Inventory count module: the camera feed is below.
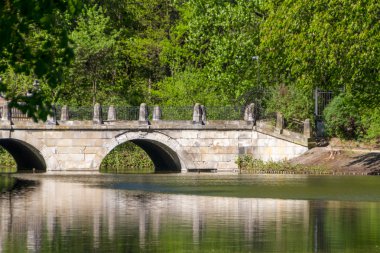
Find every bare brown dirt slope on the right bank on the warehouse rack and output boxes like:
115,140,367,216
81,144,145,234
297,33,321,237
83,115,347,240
290,146,380,175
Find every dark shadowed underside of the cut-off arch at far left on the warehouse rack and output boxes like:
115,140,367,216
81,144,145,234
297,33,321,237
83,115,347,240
0,139,46,172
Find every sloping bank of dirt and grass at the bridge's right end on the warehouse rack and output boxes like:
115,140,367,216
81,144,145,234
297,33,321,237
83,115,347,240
237,138,380,175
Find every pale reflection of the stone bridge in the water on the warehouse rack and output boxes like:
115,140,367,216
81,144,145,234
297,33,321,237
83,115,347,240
0,179,309,252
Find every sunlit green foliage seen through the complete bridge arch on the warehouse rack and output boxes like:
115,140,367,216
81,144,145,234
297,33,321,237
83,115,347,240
100,142,154,173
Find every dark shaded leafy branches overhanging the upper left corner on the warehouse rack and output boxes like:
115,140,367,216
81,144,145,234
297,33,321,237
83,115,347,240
0,0,79,119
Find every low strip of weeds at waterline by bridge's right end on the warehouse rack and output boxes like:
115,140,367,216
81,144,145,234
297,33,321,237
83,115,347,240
236,155,332,174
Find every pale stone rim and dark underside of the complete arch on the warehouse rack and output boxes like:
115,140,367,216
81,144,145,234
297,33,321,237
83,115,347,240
99,131,194,172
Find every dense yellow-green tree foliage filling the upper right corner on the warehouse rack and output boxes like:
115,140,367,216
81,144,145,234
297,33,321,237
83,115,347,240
260,0,380,106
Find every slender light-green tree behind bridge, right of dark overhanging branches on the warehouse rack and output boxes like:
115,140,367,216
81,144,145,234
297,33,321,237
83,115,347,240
65,5,119,104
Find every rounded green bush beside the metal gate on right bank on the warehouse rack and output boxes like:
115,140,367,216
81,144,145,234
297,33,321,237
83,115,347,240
324,93,364,139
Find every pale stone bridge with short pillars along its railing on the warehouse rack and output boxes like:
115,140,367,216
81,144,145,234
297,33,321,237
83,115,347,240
0,104,311,172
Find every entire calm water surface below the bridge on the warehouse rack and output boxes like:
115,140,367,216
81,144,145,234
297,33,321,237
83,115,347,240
0,174,380,253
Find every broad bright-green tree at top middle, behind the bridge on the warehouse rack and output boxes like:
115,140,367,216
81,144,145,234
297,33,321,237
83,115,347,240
156,0,261,105
